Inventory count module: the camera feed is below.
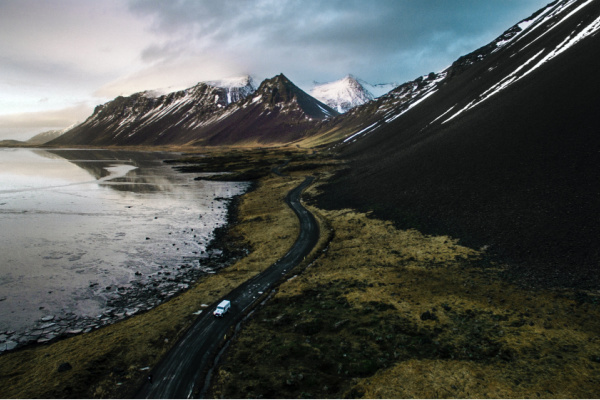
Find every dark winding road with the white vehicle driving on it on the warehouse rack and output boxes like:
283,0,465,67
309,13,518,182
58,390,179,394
137,177,319,399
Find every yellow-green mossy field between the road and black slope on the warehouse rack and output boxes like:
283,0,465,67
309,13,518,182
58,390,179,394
212,166,600,398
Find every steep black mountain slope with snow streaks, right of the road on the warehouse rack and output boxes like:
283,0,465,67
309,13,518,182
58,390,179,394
321,0,600,288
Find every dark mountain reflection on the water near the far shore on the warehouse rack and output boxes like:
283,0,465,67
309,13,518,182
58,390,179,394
40,149,184,193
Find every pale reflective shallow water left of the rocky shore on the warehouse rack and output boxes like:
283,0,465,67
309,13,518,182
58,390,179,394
0,149,247,336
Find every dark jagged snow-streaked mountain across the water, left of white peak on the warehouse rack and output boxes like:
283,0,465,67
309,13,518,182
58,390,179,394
50,75,337,146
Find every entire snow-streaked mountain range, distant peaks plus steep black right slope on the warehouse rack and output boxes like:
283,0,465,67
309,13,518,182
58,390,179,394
44,0,600,287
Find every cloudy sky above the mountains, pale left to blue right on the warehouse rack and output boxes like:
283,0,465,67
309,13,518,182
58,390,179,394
0,0,551,140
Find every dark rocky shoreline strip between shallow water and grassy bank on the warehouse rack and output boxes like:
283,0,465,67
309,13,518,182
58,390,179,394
0,155,255,355
